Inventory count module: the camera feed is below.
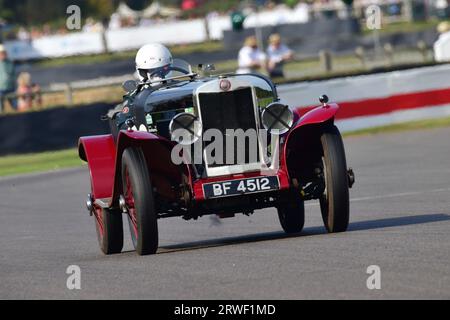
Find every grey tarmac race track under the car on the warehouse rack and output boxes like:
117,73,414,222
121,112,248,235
0,128,450,299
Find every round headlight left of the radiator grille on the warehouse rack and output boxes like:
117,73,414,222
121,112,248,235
169,112,202,145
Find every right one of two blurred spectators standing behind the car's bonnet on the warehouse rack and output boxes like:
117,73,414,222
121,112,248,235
267,33,294,78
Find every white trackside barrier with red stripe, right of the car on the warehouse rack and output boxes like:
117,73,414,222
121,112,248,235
278,65,450,131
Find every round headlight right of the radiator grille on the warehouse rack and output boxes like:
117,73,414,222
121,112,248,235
261,102,294,134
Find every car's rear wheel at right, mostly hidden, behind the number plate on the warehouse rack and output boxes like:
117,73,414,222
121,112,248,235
277,194,305,233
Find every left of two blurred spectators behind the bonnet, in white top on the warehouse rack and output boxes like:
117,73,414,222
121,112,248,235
236,36,266,73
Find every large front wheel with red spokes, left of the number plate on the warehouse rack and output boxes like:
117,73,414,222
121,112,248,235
122,148,158,255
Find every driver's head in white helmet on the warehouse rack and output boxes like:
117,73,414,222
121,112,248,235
136,43,173,81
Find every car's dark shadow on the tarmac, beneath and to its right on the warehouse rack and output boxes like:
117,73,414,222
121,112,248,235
158,213,450,254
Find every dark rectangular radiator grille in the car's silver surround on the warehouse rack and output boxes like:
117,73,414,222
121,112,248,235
199,88,259,167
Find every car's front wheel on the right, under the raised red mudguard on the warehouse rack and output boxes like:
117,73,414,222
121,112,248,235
320,125,350,232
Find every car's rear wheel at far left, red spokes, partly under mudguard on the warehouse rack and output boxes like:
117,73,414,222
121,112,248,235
94,207,123,254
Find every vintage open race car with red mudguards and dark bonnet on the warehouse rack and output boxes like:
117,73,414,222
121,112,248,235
79,61,354,255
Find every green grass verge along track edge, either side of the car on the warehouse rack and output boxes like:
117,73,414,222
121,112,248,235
0,117,450,177
